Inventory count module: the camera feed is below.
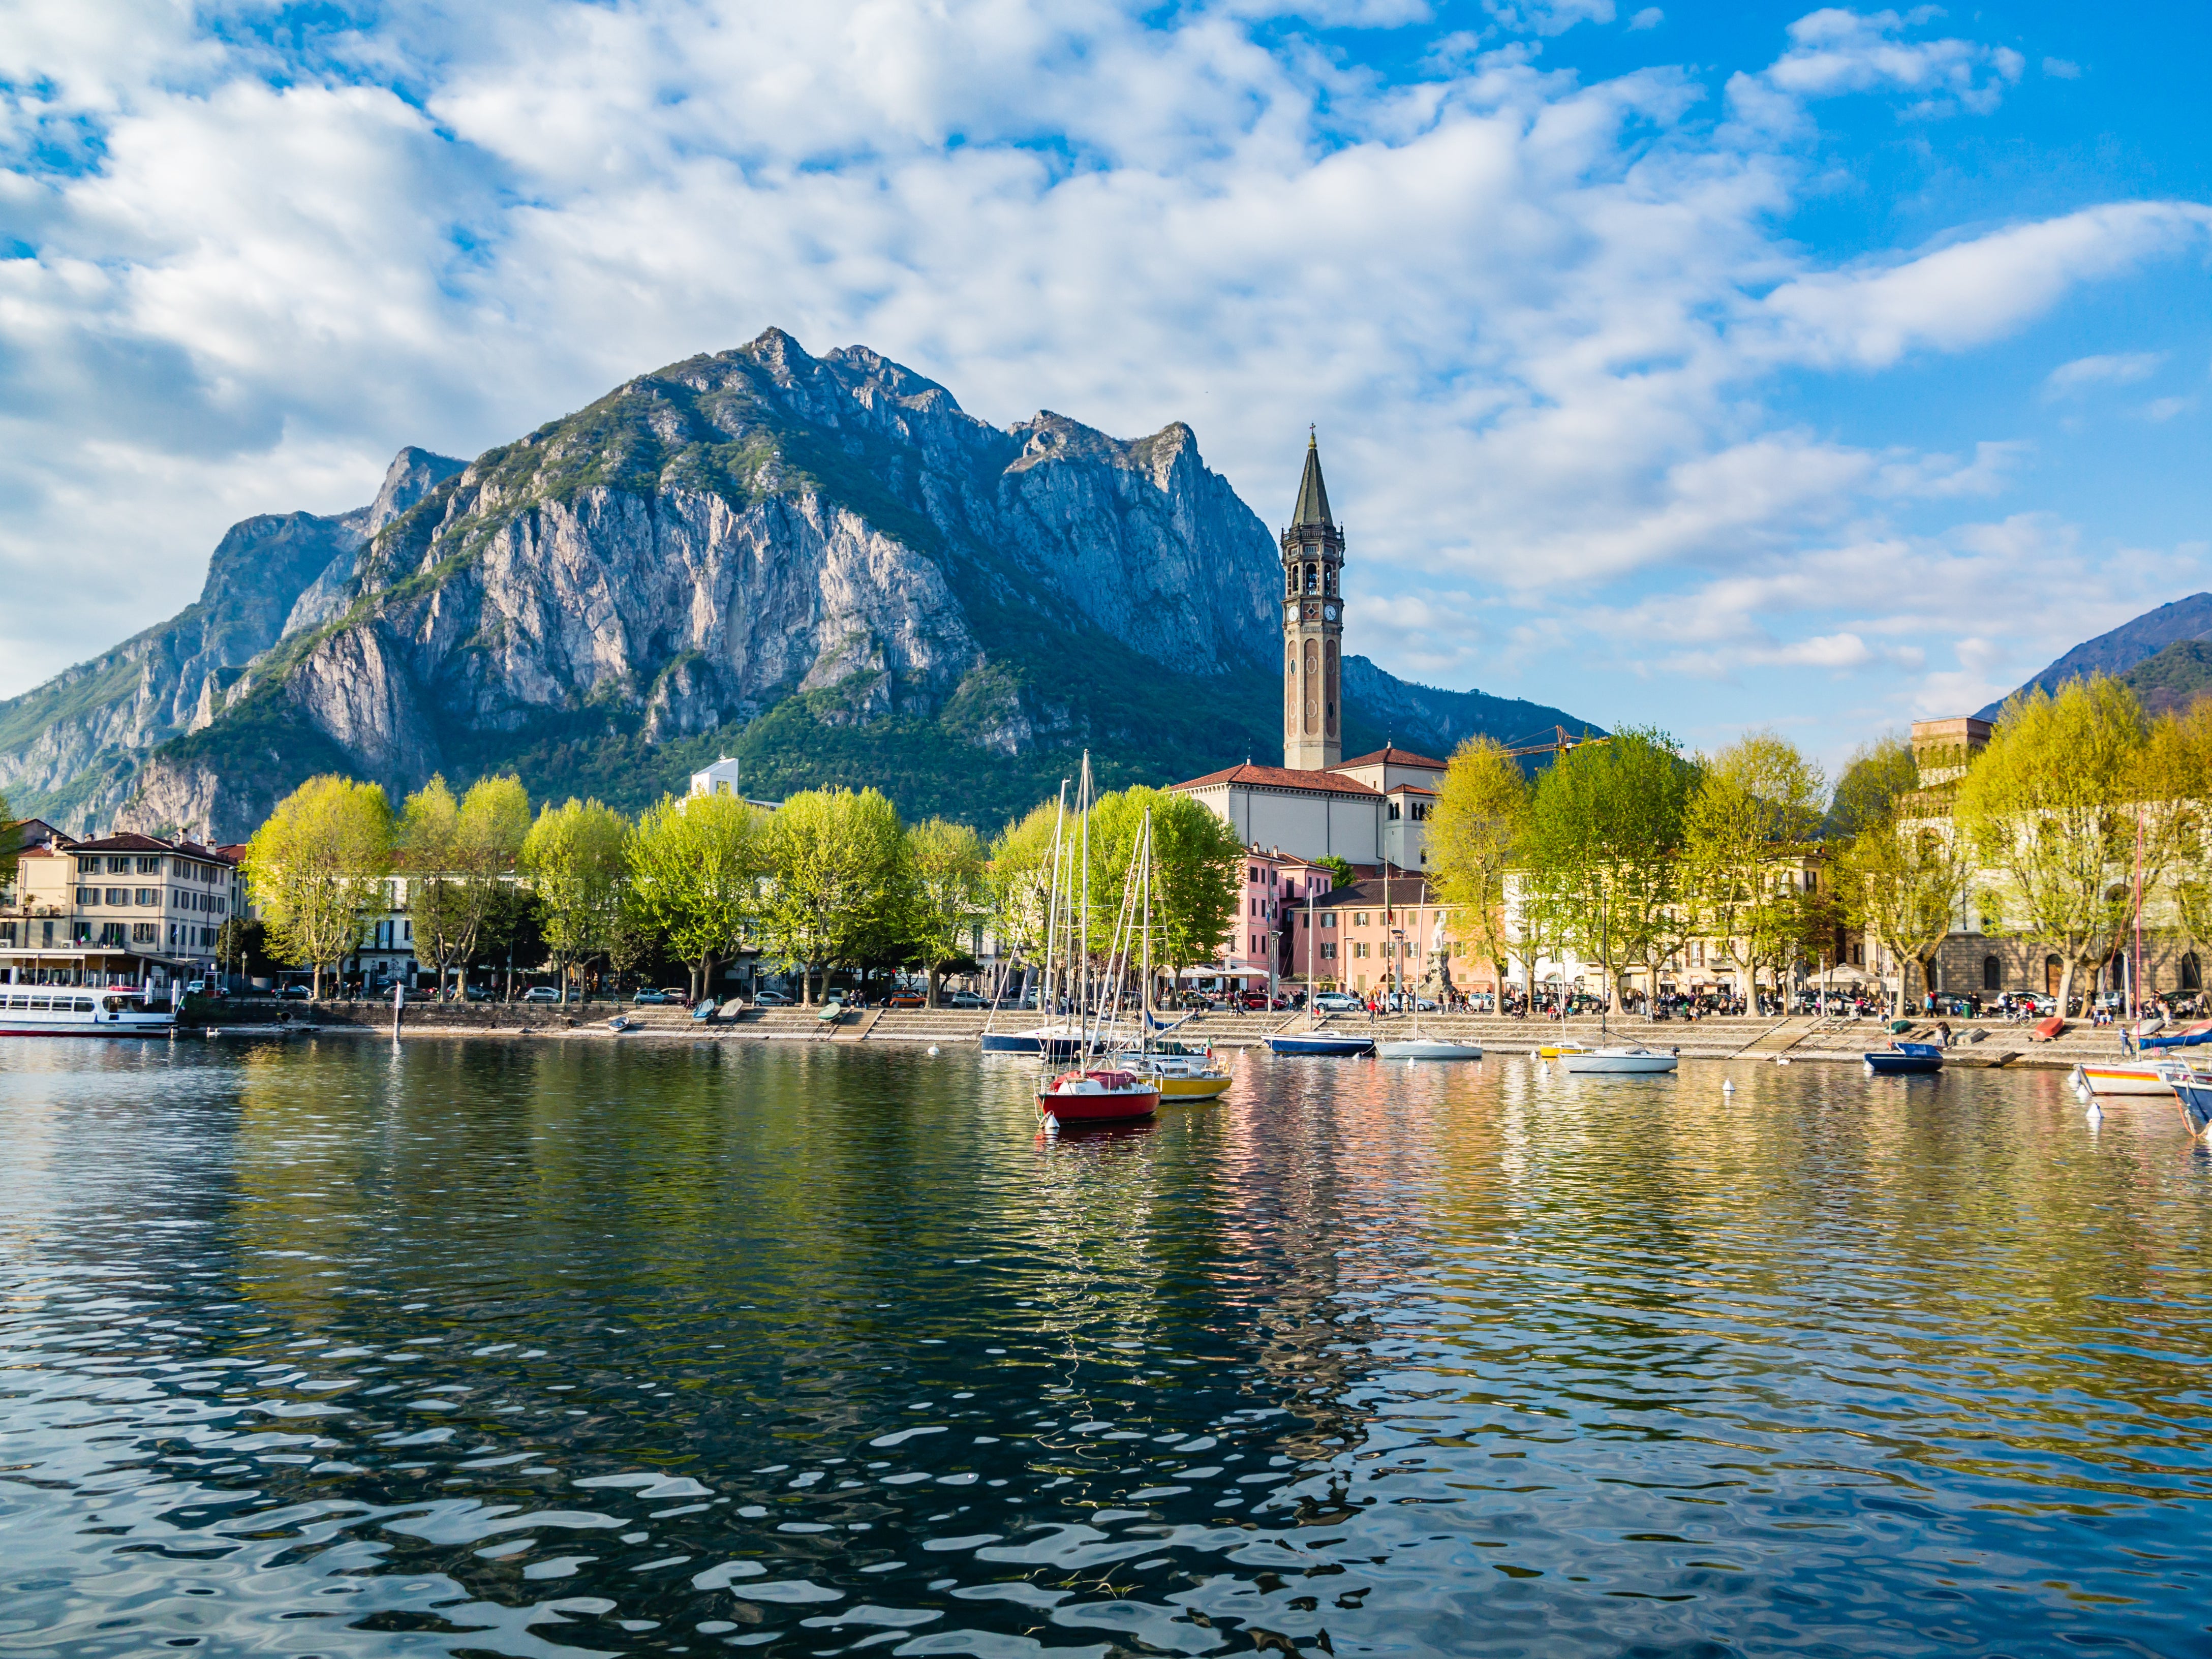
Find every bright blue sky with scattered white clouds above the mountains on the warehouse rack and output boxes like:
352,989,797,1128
0,0,2212,756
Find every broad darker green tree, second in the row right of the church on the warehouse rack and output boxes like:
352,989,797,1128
1524,728,1697,1013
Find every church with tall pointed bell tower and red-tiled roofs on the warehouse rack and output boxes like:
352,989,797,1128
1175,438,1445,872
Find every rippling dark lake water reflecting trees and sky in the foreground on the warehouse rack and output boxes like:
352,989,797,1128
0,1037,2212,1659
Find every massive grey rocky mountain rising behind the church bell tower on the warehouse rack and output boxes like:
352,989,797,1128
0,329,1579,838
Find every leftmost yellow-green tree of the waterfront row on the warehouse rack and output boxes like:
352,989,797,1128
245,774,391,1000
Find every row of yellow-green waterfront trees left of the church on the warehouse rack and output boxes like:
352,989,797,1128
245,777,1241,1006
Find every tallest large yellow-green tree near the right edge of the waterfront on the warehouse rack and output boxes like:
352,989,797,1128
1958,674,2170,1013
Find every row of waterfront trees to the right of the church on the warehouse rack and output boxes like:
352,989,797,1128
1431,677,2212,1022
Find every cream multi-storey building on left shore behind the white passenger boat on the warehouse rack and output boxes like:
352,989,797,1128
0,834,245,989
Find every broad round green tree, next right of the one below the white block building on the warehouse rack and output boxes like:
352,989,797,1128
763,790,907,1006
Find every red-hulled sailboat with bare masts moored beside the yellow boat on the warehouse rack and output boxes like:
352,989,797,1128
1037,750,1159,1128
